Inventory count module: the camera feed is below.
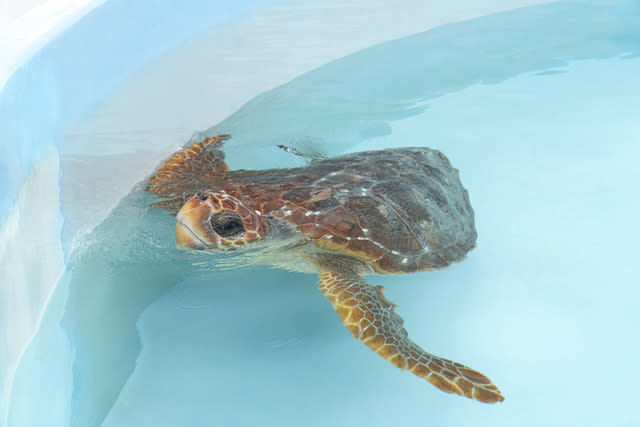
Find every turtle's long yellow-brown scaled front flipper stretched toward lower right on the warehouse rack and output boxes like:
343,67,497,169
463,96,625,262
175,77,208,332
319,269,504,403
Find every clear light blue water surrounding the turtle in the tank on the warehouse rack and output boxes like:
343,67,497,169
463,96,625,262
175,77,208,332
6,1,640,426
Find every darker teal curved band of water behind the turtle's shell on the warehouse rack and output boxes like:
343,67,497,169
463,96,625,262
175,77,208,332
204,1,640,167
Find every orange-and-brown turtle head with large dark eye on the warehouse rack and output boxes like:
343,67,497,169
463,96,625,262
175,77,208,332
176,191,269,250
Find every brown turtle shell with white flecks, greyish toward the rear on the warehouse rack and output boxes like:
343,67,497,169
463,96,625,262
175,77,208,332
219,147,476,273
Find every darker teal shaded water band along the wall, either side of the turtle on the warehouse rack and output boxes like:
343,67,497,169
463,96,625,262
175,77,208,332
56,1,640,426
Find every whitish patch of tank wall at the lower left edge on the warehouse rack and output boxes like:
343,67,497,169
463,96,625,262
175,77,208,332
0,150,64,425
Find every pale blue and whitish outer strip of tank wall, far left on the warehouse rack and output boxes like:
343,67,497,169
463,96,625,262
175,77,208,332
0,1,272,422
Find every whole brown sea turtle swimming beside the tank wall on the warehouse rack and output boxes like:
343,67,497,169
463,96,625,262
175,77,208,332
148,135,504,403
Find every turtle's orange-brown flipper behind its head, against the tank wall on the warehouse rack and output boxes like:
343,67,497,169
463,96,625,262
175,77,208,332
147,135,231,215
